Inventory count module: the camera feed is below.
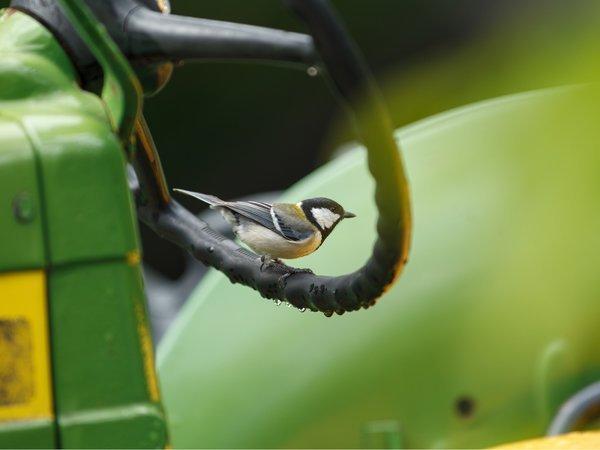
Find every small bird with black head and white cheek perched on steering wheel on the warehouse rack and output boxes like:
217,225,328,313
173,189,356,261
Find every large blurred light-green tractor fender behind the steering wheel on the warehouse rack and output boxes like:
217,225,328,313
158,88,600,448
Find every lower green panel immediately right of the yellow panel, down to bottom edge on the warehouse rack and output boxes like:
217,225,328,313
49,261,166,448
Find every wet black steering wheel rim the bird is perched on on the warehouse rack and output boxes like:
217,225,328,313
133,0,411,316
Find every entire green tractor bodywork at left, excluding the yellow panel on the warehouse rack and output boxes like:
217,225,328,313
0,11,167,448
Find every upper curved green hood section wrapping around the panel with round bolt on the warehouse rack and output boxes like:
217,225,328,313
0,9,139,264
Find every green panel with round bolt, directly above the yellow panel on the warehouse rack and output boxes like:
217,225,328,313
0,118,46,271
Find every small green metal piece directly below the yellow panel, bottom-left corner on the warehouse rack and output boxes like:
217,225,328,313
0,419,56,448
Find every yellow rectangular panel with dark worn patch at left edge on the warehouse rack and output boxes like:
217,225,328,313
0,270,54,421
